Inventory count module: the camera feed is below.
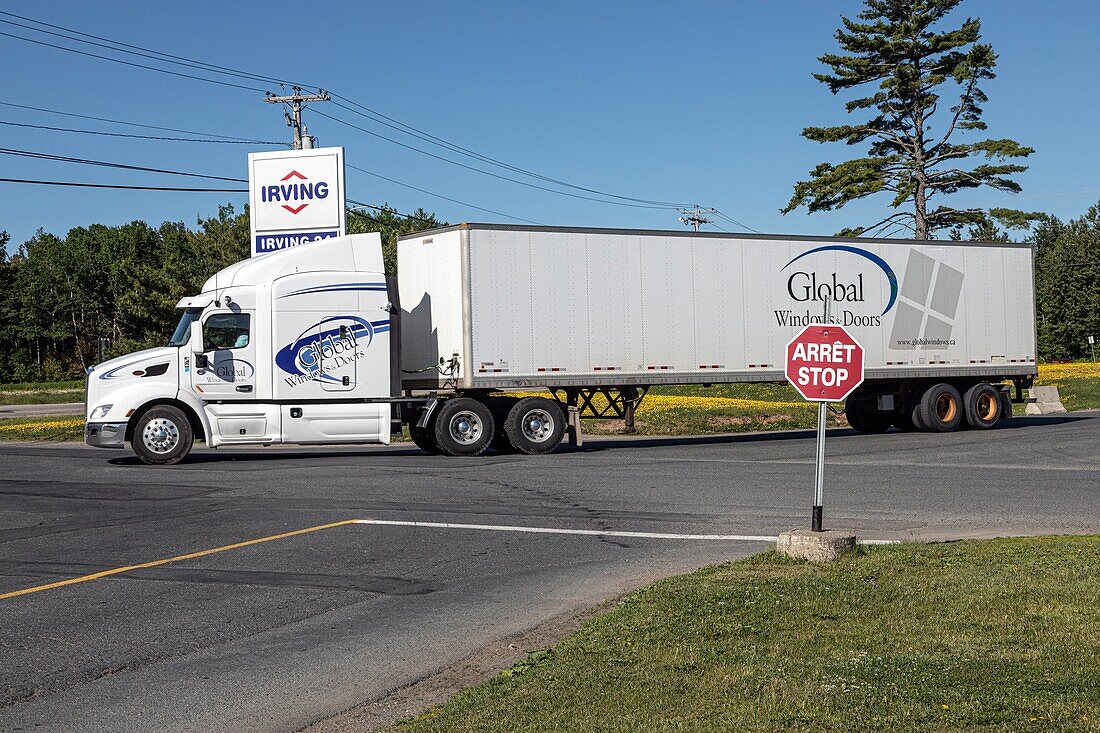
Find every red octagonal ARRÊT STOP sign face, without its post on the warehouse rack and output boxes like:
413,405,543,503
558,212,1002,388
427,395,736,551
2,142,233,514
787,325,864,402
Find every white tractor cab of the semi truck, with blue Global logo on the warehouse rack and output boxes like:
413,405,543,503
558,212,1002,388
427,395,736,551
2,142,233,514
85,233,399,463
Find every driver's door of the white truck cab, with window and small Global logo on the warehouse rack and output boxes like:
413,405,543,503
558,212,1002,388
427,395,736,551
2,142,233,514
191,311,256,398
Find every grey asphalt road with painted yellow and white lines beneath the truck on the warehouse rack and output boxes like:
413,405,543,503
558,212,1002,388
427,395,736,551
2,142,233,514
0,413,1100,733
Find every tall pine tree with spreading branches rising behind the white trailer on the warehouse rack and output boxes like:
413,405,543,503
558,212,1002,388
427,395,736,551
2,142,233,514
783,0,1037,239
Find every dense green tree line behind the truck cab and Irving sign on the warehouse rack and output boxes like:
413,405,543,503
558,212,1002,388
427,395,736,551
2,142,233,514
0,206,443,383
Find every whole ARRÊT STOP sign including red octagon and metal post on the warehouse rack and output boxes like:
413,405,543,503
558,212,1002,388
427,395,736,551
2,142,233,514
787,319,864,532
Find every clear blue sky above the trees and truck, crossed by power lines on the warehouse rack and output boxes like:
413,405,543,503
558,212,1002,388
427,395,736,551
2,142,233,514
0,0,1100,243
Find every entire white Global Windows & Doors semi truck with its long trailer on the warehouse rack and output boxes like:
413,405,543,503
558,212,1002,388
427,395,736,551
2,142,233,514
85,223,1036,463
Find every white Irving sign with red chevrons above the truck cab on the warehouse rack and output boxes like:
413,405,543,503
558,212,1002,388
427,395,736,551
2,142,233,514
249,147,347,256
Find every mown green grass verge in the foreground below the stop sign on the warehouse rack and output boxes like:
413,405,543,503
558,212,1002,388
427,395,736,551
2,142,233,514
396,530,1100,733
